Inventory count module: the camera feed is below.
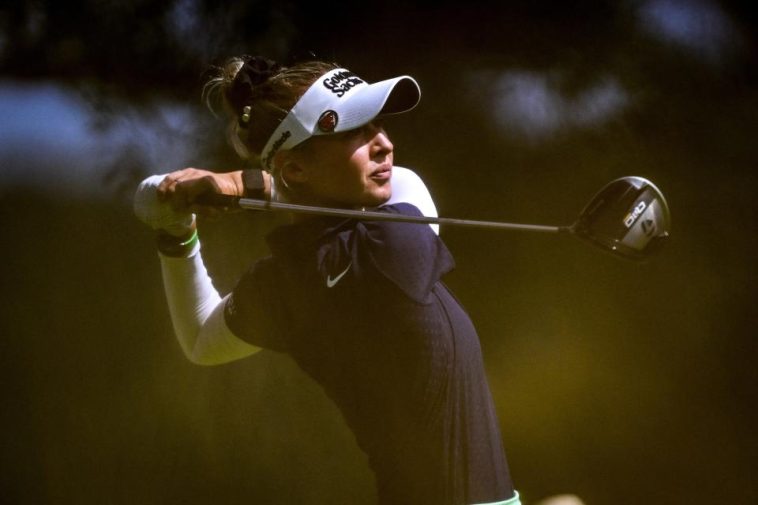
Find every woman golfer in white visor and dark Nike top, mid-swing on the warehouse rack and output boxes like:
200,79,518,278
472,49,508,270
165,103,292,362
135,57,520,505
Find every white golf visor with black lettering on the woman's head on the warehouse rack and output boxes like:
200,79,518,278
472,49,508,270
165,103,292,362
261,68,421,170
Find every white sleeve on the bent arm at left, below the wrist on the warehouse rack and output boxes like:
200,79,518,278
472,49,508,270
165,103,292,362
159,245,260,365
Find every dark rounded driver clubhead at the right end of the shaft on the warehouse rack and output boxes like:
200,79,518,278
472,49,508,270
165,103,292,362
571,177,671,260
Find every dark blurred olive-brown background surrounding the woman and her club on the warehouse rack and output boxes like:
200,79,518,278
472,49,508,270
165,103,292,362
0,0,758,505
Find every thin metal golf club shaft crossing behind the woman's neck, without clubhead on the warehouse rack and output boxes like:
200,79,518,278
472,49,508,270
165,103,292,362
202,195,570,233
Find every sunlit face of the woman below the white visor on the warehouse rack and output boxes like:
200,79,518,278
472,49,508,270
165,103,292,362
283,121,394,208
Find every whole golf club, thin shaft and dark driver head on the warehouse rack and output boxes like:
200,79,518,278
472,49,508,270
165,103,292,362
201,176,671,260
